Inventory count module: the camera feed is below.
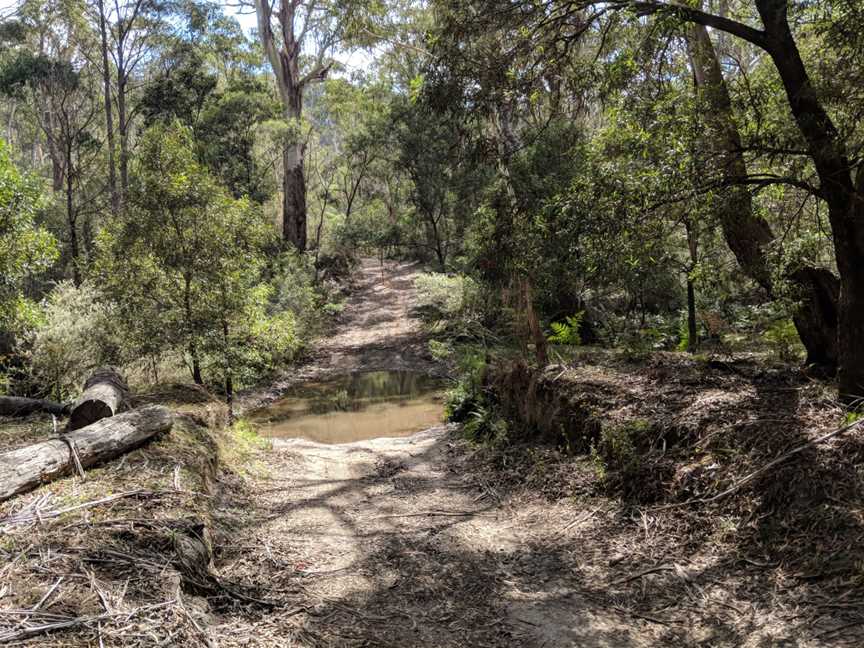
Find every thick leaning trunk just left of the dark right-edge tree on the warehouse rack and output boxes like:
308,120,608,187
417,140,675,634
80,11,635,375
687,24,838,374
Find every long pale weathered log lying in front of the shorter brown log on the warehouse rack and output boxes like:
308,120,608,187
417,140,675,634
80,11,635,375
0,405,174,502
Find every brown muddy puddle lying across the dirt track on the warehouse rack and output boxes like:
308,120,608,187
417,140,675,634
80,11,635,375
249,371,444,443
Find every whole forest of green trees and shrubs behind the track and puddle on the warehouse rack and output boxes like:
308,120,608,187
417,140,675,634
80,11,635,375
0,0,864,401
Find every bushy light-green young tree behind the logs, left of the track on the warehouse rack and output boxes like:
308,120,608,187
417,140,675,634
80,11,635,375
96,122,276,390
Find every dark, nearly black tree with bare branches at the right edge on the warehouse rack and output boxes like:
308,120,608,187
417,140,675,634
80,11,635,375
600,0,864,399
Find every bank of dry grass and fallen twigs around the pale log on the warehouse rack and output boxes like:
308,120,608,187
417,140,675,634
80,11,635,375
0,385,269,646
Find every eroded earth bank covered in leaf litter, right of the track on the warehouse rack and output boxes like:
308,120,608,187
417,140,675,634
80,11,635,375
462,352,864,646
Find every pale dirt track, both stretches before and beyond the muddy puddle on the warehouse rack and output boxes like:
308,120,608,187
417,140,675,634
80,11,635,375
211,262,649,647
